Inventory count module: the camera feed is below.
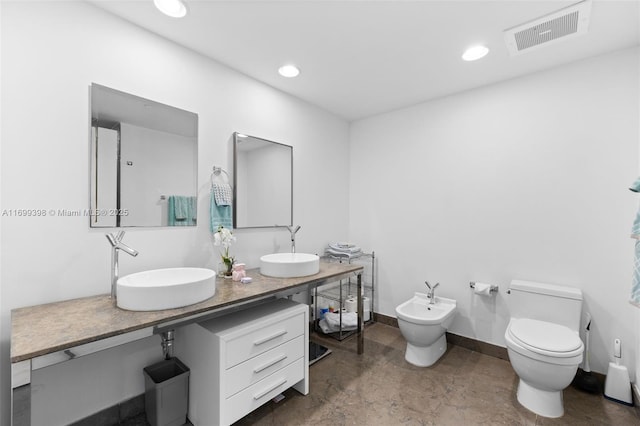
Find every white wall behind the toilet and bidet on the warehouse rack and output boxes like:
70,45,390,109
349,50,640,377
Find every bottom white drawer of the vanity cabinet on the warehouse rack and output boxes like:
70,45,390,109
222,357,305,425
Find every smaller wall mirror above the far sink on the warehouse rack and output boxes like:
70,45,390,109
233,132,293,228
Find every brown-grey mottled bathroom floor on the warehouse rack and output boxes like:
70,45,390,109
123,323,640,426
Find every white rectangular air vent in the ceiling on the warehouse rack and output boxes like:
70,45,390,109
504,0,591,55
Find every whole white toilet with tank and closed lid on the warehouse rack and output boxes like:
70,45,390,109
504,280,584,417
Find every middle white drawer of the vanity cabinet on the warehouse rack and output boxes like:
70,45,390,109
223,336,304,398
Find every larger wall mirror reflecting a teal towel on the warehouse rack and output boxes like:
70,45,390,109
89,83,198,227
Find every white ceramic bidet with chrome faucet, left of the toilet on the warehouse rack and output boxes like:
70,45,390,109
396,293,457,367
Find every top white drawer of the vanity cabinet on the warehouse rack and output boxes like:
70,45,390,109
225,313,305,368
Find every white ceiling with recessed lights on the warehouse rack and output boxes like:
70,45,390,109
88,0,640,121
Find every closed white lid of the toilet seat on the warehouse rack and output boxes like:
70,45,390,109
509,318,583,356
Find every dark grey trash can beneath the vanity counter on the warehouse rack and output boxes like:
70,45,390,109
143,358,190,426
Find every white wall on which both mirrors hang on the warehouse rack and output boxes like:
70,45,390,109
0,2,348,425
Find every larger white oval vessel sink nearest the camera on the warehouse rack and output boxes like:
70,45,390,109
116,268,216,311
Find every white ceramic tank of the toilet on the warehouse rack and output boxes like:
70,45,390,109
507,280,582,331
